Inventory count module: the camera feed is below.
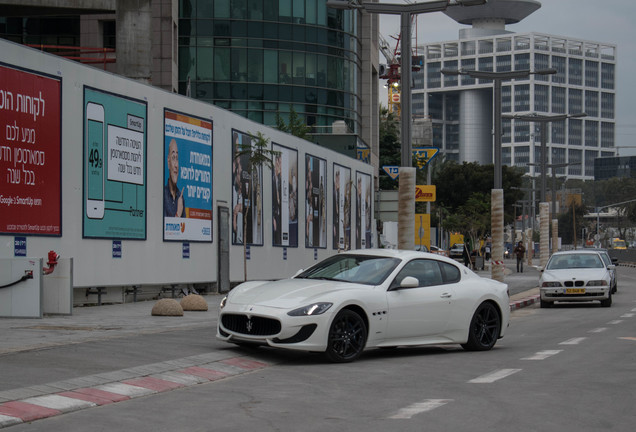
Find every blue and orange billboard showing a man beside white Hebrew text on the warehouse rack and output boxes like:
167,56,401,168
163,110,212,242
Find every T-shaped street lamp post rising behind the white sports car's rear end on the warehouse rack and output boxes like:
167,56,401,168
441,69,557,282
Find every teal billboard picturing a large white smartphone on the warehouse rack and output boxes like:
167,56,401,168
83,87,147,240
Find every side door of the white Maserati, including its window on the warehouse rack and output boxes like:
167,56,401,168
387,259,454,339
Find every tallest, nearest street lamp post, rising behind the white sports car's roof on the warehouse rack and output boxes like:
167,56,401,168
327,0,486,250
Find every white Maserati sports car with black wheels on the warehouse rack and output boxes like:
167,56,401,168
217,249,510,362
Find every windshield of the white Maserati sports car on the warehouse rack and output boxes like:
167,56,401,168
296,254,400,285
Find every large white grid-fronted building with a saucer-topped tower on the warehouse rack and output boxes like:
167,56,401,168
413,0,617,179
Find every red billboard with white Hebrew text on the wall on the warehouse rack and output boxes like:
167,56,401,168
0,66,62,236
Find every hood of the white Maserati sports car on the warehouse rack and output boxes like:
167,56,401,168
228,279,371,309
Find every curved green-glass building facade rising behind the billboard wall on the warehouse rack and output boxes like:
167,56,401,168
178,0,362,134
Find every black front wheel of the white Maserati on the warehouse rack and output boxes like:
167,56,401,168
325,309,367,363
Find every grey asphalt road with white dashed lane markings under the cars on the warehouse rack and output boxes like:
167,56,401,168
0,267,636,432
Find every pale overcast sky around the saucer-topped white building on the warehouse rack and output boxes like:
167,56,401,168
380,0,636,155
